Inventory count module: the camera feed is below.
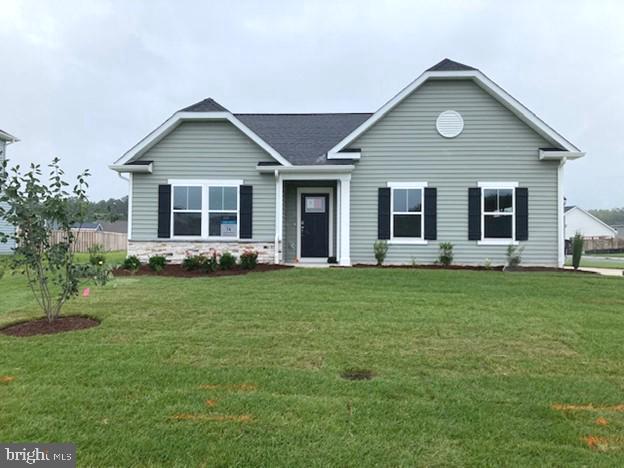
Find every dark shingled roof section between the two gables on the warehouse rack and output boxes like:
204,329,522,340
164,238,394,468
235,114,373,165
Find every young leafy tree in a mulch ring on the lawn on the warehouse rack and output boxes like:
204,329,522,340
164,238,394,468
0,158,90,322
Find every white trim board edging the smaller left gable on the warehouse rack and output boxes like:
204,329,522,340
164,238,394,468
114,111,291,166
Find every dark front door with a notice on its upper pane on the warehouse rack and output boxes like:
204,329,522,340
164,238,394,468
301,193,329,258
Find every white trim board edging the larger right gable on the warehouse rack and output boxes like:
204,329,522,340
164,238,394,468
327,70,581,159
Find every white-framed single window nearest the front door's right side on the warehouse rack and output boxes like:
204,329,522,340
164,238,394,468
388,182,427,243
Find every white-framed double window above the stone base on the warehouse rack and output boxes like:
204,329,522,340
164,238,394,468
169,179,243,240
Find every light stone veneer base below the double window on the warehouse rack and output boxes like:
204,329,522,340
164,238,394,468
128,240,275,263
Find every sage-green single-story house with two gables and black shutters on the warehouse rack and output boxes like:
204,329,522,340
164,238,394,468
110,59,584,266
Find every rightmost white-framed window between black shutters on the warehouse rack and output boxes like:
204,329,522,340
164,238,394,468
479,182,518,244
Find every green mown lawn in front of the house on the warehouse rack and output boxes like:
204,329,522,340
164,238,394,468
0,269,624,466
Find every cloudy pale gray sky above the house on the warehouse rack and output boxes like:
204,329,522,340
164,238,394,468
0,0,624,208
